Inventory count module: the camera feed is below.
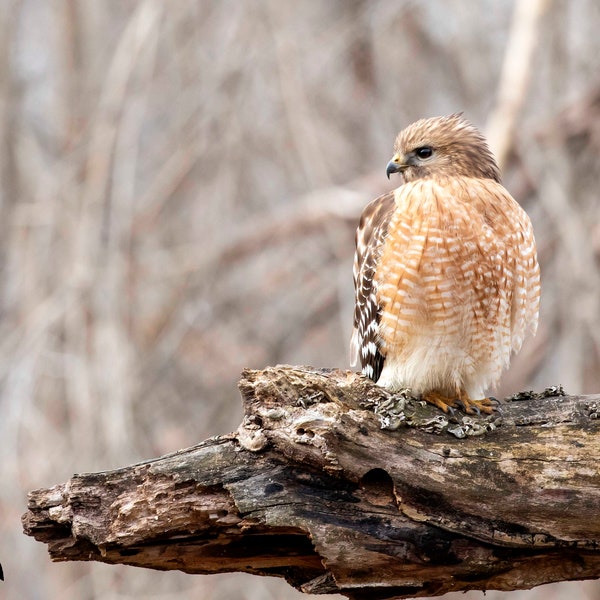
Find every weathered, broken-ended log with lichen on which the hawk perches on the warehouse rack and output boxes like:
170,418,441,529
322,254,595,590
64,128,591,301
23,367,600,599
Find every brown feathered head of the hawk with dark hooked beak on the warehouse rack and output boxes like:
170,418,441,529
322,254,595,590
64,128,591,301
386,113,500,182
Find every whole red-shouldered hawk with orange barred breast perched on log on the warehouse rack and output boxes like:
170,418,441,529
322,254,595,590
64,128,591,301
351,114,540,413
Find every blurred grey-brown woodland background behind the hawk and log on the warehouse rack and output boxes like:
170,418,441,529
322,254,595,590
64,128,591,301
0,0,600,600
